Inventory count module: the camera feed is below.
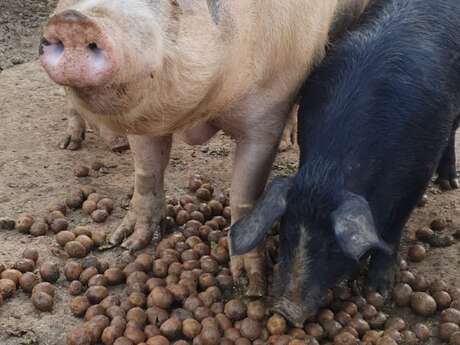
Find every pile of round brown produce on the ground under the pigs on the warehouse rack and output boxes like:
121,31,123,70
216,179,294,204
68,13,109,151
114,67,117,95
0,175,460,345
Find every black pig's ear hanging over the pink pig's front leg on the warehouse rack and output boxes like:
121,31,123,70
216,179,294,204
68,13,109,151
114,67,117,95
229,177,293,255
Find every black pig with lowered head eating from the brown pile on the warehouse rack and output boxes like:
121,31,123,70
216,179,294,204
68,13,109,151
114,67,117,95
230,0,460,326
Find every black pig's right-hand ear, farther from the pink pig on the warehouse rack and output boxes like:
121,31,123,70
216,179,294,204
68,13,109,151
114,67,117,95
332,192,391,260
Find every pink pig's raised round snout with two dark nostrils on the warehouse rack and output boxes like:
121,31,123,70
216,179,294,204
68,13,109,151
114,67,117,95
39,10,118,88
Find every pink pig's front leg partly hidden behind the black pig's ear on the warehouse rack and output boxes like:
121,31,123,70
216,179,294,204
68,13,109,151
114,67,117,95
230,141,278,297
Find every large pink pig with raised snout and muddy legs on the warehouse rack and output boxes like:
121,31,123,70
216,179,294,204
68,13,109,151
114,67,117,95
40,0,367,296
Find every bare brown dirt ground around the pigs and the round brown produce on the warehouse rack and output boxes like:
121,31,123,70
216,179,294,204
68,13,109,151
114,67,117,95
0,0,460,345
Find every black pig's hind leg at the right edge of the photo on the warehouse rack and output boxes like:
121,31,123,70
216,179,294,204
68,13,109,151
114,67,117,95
437,125,460,190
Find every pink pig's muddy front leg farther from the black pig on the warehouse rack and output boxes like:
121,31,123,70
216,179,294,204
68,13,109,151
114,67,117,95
110,135,172,251
